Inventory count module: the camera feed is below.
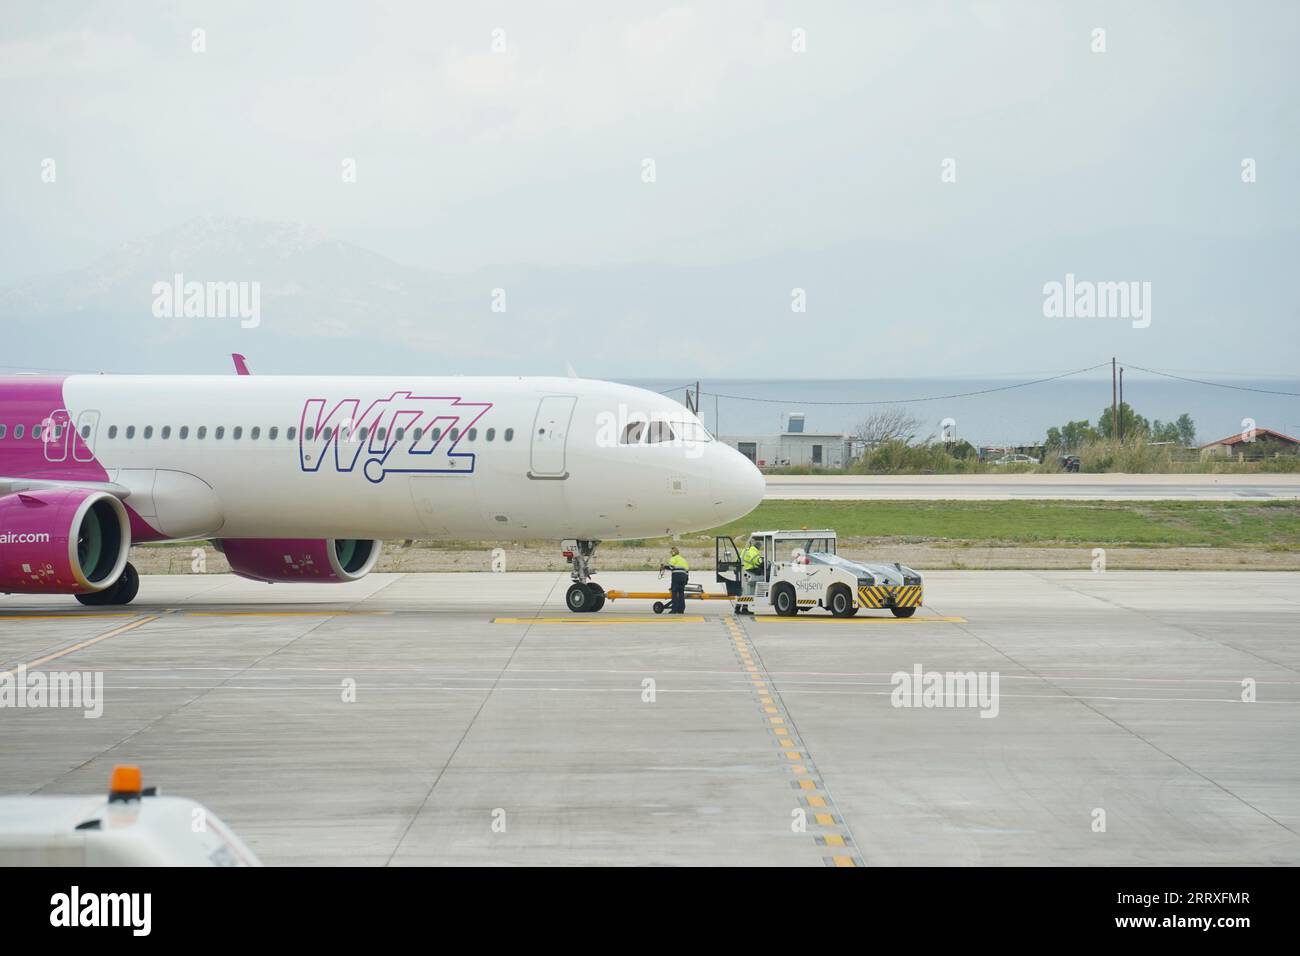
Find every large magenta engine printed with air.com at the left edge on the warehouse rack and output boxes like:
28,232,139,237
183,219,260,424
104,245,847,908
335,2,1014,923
0,488,131,594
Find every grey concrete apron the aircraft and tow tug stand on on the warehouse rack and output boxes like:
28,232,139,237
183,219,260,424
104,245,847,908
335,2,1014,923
0,571,1300,866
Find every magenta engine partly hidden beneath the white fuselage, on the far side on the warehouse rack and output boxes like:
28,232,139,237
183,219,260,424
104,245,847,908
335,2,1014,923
216,537,382,584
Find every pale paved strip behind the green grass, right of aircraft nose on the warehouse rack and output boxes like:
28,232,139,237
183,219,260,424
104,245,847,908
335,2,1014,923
766,475,1300,501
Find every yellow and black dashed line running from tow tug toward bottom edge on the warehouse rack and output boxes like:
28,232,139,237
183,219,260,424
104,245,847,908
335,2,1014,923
723,617,865,866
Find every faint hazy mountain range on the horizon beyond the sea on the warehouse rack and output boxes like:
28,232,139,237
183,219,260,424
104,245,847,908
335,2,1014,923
0,217,1300,378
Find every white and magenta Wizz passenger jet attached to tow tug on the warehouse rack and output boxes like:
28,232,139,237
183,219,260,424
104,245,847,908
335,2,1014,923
0,369,763,611
